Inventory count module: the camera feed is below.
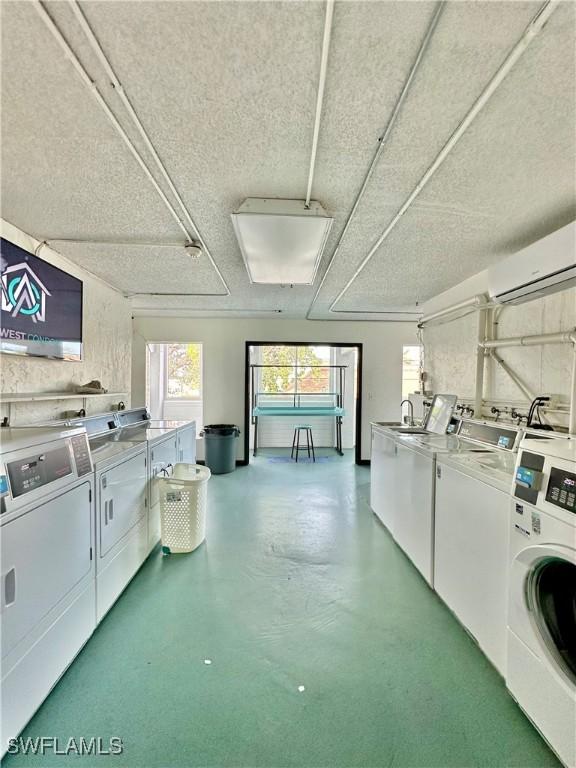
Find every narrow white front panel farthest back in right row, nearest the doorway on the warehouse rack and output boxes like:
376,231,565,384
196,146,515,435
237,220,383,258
370,429,397,535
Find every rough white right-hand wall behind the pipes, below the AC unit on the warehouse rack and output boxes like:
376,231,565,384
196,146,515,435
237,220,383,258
423,272,576,426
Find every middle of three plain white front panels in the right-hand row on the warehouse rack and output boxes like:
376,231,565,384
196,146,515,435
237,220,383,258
394,443,436,585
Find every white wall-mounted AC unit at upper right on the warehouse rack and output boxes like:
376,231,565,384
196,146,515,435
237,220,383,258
488,221,576,304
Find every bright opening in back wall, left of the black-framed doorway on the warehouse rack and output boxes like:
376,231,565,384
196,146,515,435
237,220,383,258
146,342,204,437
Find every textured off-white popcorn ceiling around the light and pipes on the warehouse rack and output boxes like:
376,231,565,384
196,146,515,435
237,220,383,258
0,0,576,319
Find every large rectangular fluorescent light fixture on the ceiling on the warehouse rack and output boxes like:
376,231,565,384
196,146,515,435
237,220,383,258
232,197,334,285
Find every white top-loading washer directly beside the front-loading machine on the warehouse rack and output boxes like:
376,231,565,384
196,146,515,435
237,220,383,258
434,436,516,675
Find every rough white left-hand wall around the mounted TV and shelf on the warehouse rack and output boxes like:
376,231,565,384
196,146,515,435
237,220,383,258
0,219,132,424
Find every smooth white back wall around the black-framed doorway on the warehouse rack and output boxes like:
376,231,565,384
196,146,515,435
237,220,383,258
132,317,416,459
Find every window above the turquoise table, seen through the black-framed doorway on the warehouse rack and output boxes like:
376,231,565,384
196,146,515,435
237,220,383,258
260,344,332,395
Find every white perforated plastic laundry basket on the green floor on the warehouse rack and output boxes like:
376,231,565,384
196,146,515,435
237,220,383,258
156,464,210,554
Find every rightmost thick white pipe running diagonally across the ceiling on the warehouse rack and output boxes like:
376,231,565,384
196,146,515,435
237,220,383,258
329,0,560,312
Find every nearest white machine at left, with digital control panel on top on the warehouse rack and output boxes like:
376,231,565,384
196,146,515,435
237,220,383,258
0,428,96,754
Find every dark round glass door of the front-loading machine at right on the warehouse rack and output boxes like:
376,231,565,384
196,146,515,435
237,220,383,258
530,558,576,682
